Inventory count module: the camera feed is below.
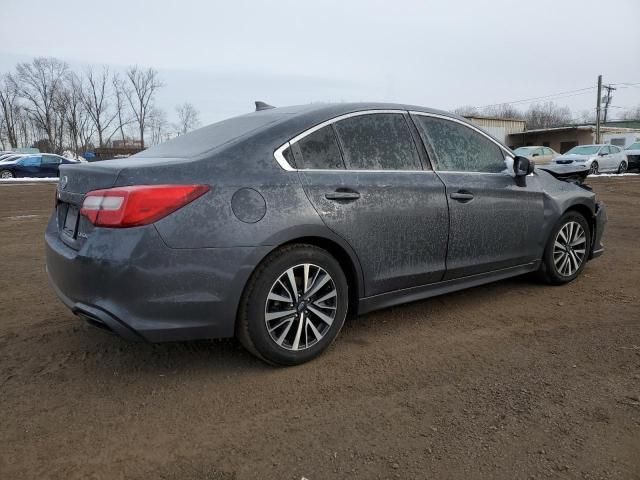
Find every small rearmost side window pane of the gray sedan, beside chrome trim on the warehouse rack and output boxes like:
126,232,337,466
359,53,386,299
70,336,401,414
291,125,344,170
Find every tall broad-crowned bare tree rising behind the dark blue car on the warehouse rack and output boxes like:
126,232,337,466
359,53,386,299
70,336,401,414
10,57,69,152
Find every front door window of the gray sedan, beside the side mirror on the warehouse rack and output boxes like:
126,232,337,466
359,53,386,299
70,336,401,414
414,115,506,173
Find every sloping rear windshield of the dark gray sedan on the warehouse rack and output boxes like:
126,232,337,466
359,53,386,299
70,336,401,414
131,112,282,159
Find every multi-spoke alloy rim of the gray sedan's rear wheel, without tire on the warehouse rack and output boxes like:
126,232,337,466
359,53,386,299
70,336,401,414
264,263,338,351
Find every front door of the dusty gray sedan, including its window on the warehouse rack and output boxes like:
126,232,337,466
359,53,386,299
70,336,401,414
412,112,544,280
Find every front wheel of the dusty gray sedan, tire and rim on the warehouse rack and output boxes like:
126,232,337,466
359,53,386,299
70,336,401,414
540,212,591,285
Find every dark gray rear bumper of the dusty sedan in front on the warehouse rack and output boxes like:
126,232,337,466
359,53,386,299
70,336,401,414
45,218,269,342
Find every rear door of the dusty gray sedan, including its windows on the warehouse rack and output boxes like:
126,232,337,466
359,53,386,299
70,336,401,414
292,111,449,296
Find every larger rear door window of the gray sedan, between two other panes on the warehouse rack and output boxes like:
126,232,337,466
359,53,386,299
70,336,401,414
334,113,422,170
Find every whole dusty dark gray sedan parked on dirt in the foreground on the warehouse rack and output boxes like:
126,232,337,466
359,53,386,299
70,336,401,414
45,104,606,364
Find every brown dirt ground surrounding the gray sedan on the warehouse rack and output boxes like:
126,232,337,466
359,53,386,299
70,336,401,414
0,177,640,480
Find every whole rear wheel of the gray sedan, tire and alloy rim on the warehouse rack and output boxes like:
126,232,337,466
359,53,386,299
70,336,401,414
236,244,349,365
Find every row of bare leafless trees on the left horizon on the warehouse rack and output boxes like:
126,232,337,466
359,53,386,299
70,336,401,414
0,57,200,154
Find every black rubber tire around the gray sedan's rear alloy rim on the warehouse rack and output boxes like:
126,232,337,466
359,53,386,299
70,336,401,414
236,244,349,366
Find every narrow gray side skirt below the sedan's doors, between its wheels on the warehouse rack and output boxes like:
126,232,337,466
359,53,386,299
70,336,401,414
358,260,541,315
